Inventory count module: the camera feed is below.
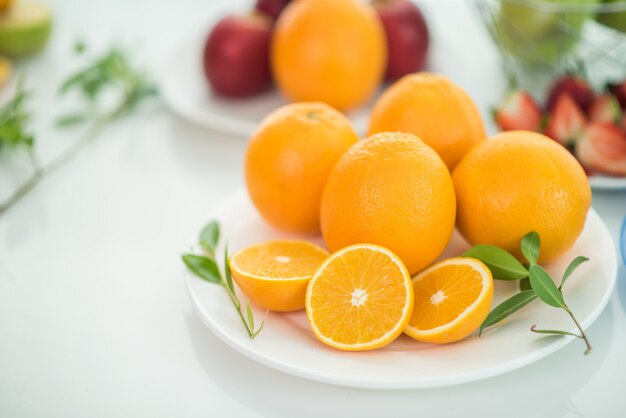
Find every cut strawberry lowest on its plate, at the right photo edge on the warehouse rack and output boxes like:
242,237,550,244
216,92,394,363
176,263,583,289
576,122,626,176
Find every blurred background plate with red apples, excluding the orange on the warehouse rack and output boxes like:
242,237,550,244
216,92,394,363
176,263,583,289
159,0,430,138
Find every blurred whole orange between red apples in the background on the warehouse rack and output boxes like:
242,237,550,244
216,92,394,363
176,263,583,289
271,0,387,110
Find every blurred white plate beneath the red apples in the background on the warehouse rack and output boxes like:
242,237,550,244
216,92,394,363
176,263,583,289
157,32,369,138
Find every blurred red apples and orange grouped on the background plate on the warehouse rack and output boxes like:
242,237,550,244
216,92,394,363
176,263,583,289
203,0,429,111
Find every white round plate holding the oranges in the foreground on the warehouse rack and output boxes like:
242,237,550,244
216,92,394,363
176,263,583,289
186,193,617,389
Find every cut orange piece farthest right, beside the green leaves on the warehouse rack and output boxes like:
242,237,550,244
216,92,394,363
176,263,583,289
404,257,493,344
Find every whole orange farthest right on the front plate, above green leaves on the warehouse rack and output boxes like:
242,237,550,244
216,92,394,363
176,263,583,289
452,131,591,262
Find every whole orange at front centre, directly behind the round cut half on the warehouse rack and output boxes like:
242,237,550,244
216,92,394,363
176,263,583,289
321,133,456,274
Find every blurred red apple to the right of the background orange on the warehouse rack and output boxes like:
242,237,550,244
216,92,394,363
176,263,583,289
372,0,430,80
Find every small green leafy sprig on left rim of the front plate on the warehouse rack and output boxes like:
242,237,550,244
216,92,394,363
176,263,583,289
182,221,268,338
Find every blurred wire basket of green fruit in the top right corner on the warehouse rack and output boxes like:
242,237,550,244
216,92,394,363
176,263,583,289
477,0,626,68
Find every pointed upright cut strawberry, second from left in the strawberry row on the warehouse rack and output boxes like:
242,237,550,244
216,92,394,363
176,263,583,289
544,94,587,149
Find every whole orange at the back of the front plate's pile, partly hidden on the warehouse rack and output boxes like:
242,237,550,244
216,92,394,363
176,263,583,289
368,73,486,170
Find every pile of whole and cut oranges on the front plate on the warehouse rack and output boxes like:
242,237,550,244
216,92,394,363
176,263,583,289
230,73,591,350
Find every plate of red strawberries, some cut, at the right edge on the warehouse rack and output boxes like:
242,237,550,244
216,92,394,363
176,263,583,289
493,74,626,190
